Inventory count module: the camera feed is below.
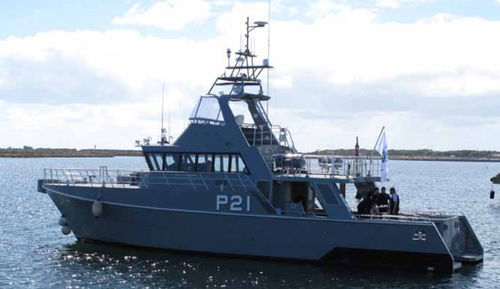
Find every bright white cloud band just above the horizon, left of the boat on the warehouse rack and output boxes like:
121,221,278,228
0,100,193,149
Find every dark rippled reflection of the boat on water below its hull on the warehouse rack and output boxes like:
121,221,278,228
47,242,478,288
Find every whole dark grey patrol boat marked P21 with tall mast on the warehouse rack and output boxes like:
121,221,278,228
38,18,483,273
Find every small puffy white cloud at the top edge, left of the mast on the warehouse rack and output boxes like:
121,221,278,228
113,0,212,30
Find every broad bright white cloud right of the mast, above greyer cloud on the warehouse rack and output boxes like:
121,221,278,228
271,10,500,96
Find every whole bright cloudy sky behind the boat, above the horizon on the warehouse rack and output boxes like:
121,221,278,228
0,0,500,151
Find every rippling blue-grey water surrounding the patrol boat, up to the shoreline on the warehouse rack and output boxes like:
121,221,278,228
0,157,500,289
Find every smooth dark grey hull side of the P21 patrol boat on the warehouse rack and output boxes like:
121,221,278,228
47,188,456,272
